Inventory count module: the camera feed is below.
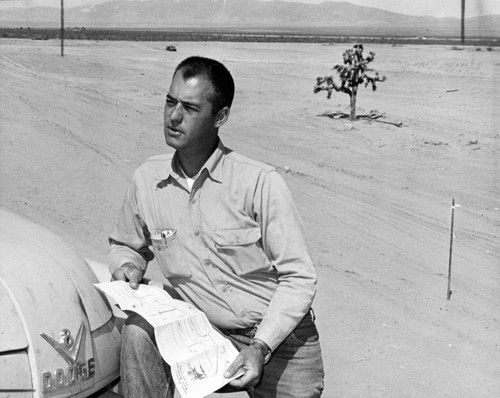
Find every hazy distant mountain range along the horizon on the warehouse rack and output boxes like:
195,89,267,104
0,0,500,37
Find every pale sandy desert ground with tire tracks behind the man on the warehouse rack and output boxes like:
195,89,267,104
0,39,500,398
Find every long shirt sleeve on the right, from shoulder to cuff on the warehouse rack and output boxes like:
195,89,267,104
255,171,316,350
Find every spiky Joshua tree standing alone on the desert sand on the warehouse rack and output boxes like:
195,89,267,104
314,44,385,119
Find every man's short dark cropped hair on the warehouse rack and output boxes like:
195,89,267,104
174,56,234,113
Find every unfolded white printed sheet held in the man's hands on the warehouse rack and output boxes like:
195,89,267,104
95,281,239,398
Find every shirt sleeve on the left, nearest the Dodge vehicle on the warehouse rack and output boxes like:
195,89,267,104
108,172,153,273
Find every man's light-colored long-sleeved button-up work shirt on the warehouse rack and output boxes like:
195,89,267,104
108,141,316,350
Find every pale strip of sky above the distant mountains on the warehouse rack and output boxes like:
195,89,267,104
0,0,500,18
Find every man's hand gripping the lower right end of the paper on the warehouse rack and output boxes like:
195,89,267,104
224,345,264,388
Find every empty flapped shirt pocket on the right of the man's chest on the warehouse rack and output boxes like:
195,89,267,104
214,227,271,275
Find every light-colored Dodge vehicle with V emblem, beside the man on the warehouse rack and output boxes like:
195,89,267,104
0,208,121,397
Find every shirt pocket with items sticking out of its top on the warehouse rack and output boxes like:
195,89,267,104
151,229,192,279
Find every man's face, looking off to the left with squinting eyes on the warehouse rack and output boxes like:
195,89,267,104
163,71,219,154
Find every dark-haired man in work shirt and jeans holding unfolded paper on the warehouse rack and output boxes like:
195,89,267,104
109,57,323,398
